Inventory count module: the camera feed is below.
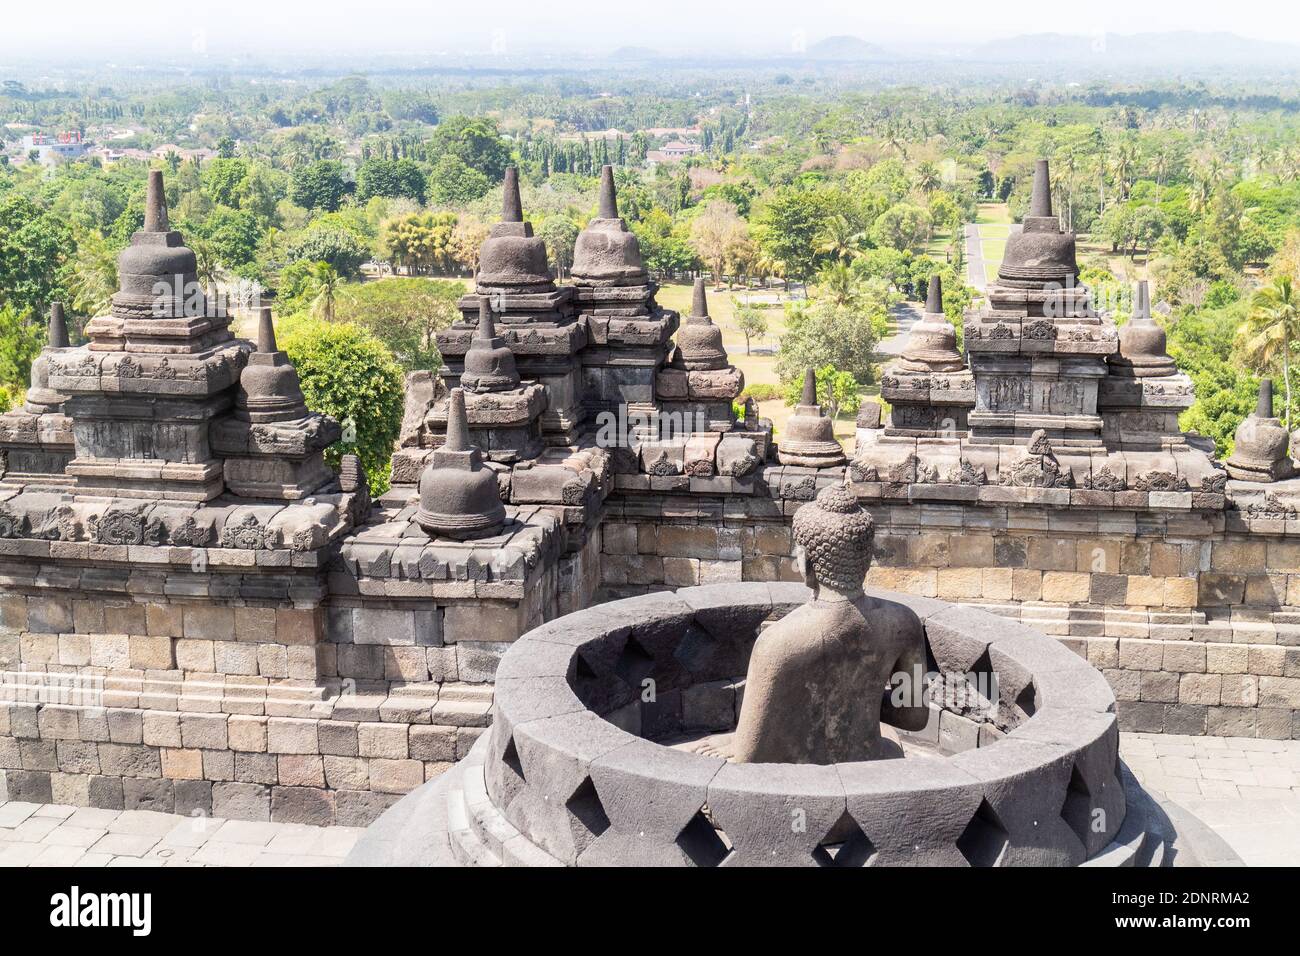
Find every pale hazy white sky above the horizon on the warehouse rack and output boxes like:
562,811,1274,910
0,0,1300,60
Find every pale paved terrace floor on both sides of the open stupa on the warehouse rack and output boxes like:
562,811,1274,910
0,734,1300,866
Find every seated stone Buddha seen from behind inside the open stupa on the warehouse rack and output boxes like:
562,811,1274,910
703,485,928,763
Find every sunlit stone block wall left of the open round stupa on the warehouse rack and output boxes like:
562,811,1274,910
0,548,501,826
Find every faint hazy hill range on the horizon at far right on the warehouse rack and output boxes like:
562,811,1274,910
970,30,1300,65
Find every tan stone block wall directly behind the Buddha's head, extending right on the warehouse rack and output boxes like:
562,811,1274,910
602,481,1300,737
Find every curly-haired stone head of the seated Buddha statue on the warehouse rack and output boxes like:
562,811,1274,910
794,485,875,600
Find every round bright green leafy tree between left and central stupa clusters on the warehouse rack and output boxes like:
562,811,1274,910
280,321,406,494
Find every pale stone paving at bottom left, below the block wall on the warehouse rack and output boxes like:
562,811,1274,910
0,801,361,866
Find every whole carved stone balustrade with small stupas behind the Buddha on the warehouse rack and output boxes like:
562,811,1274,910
0,163,1300,825
